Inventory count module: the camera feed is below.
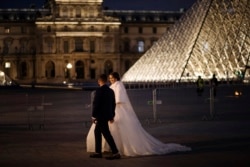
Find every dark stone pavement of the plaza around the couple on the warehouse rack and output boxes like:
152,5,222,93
0,87,250,167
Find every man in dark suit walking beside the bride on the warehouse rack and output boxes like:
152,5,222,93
90,74,121,160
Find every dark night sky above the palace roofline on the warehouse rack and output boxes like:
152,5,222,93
0,0,196,11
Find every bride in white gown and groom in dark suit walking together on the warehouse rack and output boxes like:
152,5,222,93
86,72,191,160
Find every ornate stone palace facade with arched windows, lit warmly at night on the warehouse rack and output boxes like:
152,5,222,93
0,0,184,83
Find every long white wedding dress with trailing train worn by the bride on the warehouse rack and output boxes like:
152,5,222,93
86,81,191,156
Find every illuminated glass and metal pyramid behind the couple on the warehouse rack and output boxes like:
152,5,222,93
122,0,250,82
